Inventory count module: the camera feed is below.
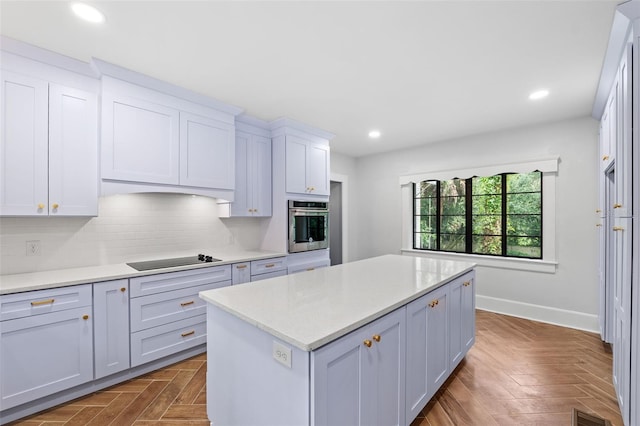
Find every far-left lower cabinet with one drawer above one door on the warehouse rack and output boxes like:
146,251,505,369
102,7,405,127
0,284,93,410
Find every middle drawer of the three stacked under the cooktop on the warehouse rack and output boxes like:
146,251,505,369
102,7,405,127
130,281,231,332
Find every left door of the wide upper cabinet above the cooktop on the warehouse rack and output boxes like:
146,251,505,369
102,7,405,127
101,91,180,185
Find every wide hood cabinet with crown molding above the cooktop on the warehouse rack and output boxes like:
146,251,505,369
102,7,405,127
94,59,242,201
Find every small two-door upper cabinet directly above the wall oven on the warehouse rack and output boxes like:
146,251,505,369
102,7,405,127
286,135,329,195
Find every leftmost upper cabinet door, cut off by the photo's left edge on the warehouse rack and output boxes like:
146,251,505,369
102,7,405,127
0,70,49,216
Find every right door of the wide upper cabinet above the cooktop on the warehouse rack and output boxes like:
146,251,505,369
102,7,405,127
180,112,235,189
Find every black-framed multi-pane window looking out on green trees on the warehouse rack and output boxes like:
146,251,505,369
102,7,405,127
413,171,542,259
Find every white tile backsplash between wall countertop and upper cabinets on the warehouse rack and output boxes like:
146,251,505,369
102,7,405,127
0,194,269,275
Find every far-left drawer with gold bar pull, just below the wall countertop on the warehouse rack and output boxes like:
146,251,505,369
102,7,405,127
0,284,91,321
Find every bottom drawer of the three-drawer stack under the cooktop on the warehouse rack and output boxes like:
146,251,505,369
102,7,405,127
131,314,207,367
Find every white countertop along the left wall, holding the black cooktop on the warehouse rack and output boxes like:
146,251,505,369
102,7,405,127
0,250,286,294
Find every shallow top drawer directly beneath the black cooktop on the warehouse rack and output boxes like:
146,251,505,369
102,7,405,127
129,265,231,297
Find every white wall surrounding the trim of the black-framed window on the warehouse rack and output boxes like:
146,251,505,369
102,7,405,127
344,118,598,331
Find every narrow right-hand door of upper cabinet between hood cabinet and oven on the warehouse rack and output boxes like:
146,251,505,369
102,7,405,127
250,136,272,217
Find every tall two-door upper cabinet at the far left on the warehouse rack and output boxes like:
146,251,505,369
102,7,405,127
0,58,98,216
